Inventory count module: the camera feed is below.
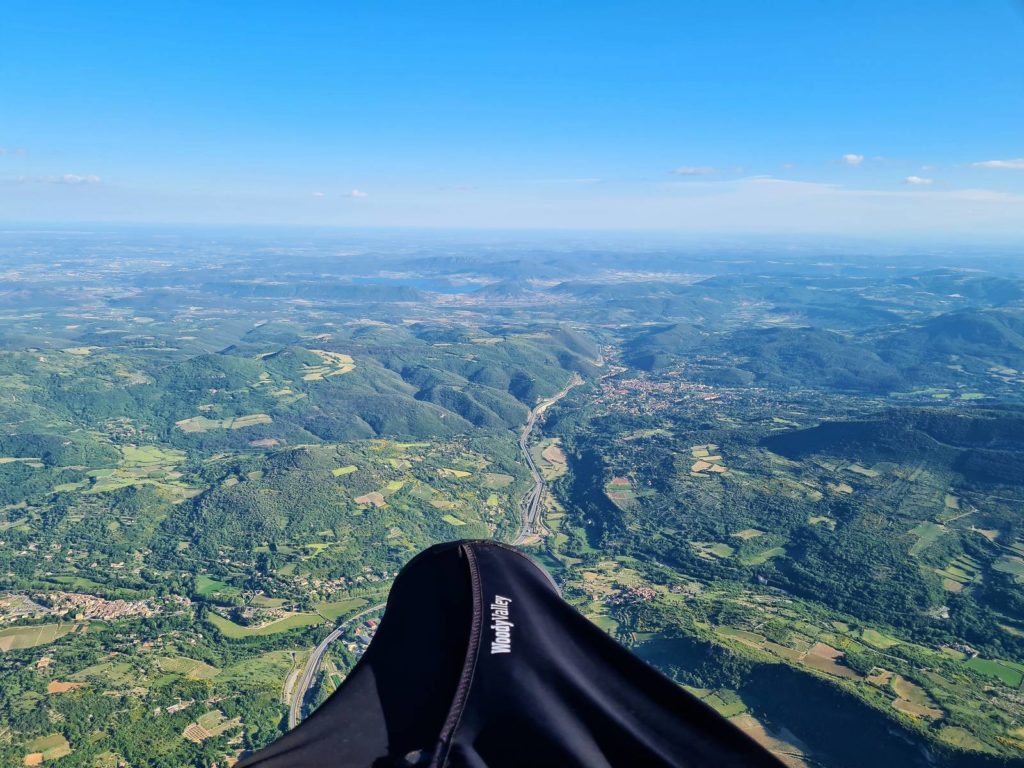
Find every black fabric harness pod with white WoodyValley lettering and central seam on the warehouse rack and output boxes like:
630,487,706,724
238,541,782,768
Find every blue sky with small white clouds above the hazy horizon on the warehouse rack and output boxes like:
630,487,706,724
6,0,1024,237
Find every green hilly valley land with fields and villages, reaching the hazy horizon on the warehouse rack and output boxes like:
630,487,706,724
0,233,1024,768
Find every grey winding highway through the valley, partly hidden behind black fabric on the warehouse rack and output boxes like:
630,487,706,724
288,374,583,730
